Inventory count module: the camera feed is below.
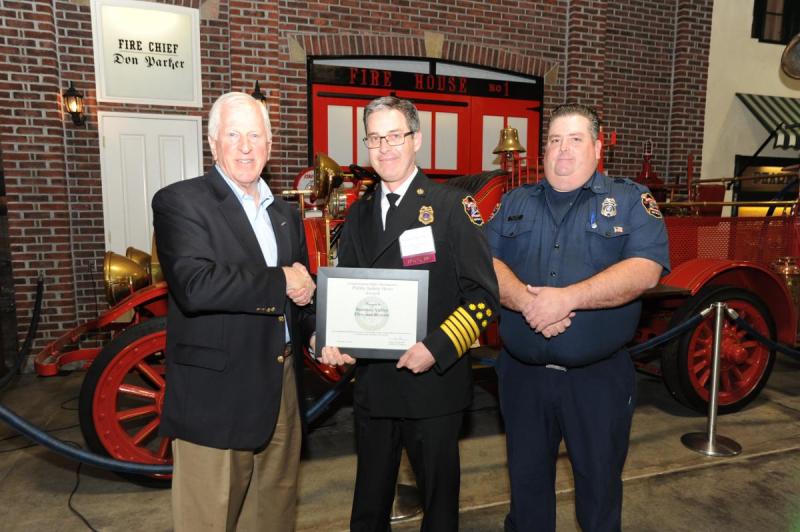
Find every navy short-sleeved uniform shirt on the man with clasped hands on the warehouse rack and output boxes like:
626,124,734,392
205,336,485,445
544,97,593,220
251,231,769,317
486,172,669,367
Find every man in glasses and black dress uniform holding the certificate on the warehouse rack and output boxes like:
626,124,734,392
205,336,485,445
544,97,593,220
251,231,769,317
320,97,499,532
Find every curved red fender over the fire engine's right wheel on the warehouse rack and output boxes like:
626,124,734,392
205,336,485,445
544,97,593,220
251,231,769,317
661,259,797,346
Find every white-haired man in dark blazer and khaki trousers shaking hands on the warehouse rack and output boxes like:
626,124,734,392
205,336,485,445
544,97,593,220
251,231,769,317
153,92,315,531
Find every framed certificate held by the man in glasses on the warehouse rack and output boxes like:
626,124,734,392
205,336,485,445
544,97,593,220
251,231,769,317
317,268,428,360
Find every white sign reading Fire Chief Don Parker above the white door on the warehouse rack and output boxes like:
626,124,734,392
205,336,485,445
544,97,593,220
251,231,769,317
91,0,202,107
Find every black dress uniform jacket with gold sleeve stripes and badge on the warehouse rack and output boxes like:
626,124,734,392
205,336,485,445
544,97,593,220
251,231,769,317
338,171,499,418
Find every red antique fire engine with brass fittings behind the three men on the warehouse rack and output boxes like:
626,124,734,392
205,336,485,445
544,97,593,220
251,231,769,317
28,130,800,478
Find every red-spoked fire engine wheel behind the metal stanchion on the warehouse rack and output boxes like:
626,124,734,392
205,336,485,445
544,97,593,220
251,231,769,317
661,286,777,414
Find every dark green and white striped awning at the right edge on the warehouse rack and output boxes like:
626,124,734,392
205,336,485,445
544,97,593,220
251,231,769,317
736,92,800,148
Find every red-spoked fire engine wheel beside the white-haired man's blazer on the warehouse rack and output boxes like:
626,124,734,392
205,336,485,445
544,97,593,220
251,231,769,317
78,317,172,488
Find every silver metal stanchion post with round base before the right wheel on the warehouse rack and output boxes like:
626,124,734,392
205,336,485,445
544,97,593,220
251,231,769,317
681,302,742,456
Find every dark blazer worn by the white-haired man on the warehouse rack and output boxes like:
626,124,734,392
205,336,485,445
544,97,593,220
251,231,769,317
153,169,314,450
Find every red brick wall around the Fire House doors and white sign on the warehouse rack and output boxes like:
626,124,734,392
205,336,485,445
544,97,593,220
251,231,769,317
0,0,713,358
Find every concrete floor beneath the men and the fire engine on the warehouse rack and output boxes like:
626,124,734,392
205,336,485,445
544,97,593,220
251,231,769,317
0,357,800,532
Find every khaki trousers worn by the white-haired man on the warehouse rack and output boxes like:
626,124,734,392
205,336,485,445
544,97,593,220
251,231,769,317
172,359,301,532
